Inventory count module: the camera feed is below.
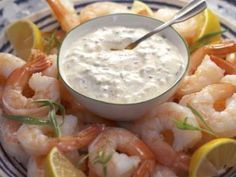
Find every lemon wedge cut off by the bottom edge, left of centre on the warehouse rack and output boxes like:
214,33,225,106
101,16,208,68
45,147,86,177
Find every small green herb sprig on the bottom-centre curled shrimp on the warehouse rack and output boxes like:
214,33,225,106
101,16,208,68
93,150,113,177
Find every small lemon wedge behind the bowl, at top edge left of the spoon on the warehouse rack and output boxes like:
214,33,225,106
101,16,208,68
131,0,154,17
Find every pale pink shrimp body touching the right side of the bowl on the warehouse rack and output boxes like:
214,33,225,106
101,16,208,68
176,56,224,97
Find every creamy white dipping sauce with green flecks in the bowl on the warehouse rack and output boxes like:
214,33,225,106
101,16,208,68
61,27,185,103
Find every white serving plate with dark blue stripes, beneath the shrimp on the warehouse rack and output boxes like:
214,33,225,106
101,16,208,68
0,0,236,177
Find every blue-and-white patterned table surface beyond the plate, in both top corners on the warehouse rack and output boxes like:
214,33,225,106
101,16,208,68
0,0,236,32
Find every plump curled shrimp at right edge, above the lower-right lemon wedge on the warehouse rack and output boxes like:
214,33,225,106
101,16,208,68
180,83,236,137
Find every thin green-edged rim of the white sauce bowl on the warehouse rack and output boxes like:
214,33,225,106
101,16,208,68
57,13,190,106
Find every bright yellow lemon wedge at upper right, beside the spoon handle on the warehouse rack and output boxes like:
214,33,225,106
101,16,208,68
197,9,221,41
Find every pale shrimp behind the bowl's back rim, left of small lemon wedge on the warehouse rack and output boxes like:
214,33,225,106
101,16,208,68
80,2,129,23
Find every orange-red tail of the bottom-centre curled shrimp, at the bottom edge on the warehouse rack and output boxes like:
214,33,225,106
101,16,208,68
133,160,155,177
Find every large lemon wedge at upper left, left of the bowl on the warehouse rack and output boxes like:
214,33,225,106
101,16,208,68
6,20,43,60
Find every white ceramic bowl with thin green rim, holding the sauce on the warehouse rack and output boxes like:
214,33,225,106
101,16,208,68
58,14,189,121
